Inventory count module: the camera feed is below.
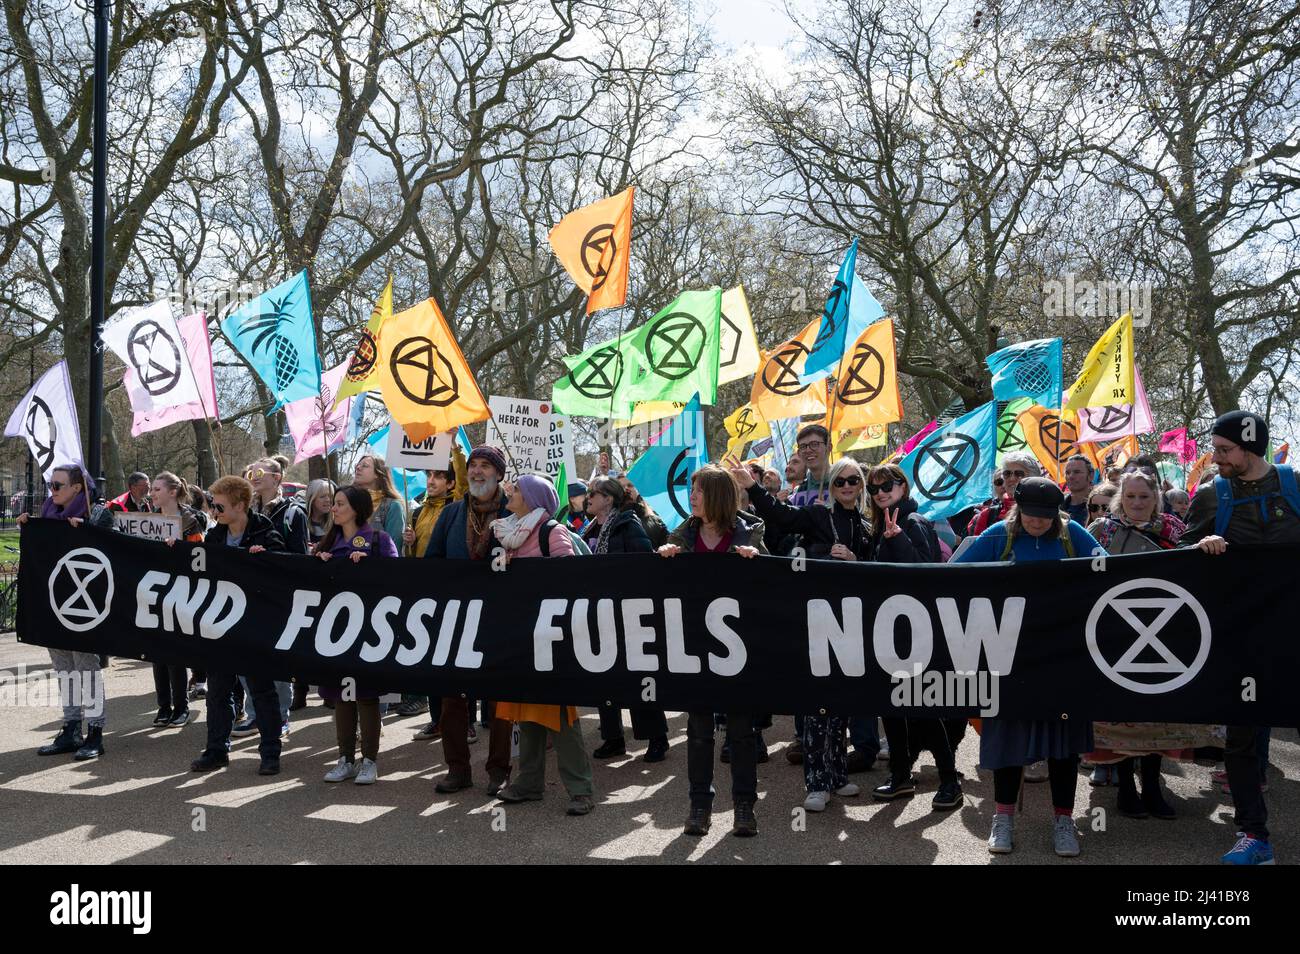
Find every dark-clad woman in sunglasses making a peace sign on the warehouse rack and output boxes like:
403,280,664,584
867,464,966,811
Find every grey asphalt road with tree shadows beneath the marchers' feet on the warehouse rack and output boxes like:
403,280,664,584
0,634,1300,864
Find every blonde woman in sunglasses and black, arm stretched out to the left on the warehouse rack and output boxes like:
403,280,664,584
728,458,875,811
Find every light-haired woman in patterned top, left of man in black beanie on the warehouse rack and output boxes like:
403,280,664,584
1087,469,1206,820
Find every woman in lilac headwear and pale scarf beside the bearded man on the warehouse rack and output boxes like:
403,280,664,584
491,473,595,815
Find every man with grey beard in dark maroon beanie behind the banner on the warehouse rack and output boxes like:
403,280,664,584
424,446,510,795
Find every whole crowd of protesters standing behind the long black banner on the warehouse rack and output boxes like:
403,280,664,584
21,411,1300,864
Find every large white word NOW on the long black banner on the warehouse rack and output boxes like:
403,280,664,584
807,594,1026,677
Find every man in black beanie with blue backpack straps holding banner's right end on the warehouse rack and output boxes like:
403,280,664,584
1179,411,1300,864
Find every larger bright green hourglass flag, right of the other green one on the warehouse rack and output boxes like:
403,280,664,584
627,287,723,404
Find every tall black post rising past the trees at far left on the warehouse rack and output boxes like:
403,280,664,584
83,0,109,501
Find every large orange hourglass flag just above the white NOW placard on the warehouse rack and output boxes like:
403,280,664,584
378,298,491,442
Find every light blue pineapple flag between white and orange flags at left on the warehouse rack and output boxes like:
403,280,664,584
221,269,321,411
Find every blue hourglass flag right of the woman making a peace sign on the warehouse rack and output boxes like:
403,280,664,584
898,400,997,520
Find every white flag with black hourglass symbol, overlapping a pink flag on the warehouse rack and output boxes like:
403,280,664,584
101,300,200,412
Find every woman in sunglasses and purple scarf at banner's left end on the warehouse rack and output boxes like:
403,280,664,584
18,464,113,762
